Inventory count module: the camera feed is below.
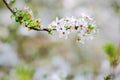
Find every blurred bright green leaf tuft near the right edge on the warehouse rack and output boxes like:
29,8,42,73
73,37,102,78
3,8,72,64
103,43,117,61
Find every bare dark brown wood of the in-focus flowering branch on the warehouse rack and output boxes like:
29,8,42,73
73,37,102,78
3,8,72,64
3,0,56,32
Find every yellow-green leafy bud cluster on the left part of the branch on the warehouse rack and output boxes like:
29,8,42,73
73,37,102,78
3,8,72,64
11,6,40,30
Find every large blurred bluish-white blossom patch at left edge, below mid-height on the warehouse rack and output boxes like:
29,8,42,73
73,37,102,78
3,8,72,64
0,43,18,66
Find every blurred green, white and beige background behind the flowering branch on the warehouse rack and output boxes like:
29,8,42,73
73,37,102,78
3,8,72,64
0,0,120,80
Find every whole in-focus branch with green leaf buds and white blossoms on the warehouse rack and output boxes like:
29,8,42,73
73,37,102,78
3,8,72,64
3,0,97,43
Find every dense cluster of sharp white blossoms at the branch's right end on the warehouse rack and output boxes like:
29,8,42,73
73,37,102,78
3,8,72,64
49,15,97,44
